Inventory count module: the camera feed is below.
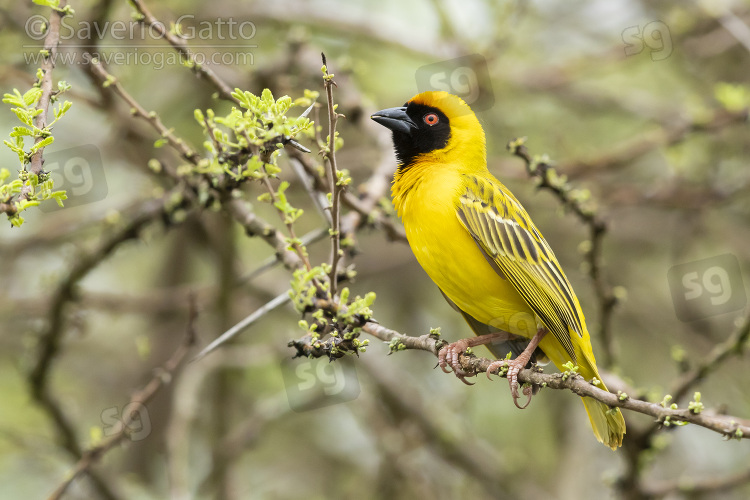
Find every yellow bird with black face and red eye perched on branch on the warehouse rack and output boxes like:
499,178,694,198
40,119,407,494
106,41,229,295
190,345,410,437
371,92,625,449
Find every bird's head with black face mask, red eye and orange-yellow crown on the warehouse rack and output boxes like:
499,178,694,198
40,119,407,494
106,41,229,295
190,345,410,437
371,91,486,170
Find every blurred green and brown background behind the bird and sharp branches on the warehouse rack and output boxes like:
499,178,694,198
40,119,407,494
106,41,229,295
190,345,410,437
0,0,750,499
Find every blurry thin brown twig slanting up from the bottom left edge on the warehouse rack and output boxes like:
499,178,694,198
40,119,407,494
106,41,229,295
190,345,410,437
49,299,198,500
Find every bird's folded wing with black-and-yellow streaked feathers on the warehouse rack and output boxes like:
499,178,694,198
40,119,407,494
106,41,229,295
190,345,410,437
457,175,585,362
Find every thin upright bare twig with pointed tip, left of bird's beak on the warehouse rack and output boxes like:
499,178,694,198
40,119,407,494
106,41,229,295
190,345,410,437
320,52,343,297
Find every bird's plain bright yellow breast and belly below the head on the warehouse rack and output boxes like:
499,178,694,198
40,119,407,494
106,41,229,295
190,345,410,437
393,162,537,337
